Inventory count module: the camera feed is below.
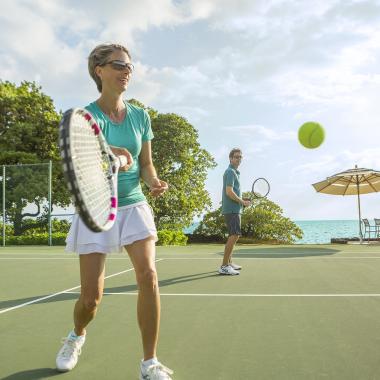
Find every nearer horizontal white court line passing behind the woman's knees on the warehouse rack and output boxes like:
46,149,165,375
63,292,380,297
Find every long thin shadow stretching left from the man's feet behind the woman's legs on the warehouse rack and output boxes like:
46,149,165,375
0,270,219,310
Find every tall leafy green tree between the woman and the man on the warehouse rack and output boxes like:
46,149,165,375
130,99,216,229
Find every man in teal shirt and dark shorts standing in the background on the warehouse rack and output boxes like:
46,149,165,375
218,148,251,276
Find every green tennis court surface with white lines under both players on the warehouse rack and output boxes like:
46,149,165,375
0,245,380,380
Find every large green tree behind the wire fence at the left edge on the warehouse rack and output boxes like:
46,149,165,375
0,81,70,235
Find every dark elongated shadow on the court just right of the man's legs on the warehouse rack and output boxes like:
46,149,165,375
218,246,341,259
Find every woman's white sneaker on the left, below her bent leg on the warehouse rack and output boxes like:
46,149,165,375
55,332,86,372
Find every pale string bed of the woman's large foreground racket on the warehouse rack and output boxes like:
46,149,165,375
70,115,112,224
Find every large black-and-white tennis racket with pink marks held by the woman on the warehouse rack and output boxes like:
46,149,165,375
59,108,127,232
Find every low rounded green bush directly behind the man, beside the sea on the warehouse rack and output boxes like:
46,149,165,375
194,193,303,244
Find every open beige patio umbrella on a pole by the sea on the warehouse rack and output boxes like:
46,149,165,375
313,165,380,242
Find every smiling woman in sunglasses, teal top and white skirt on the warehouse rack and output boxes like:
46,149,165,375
56,44,172,380
